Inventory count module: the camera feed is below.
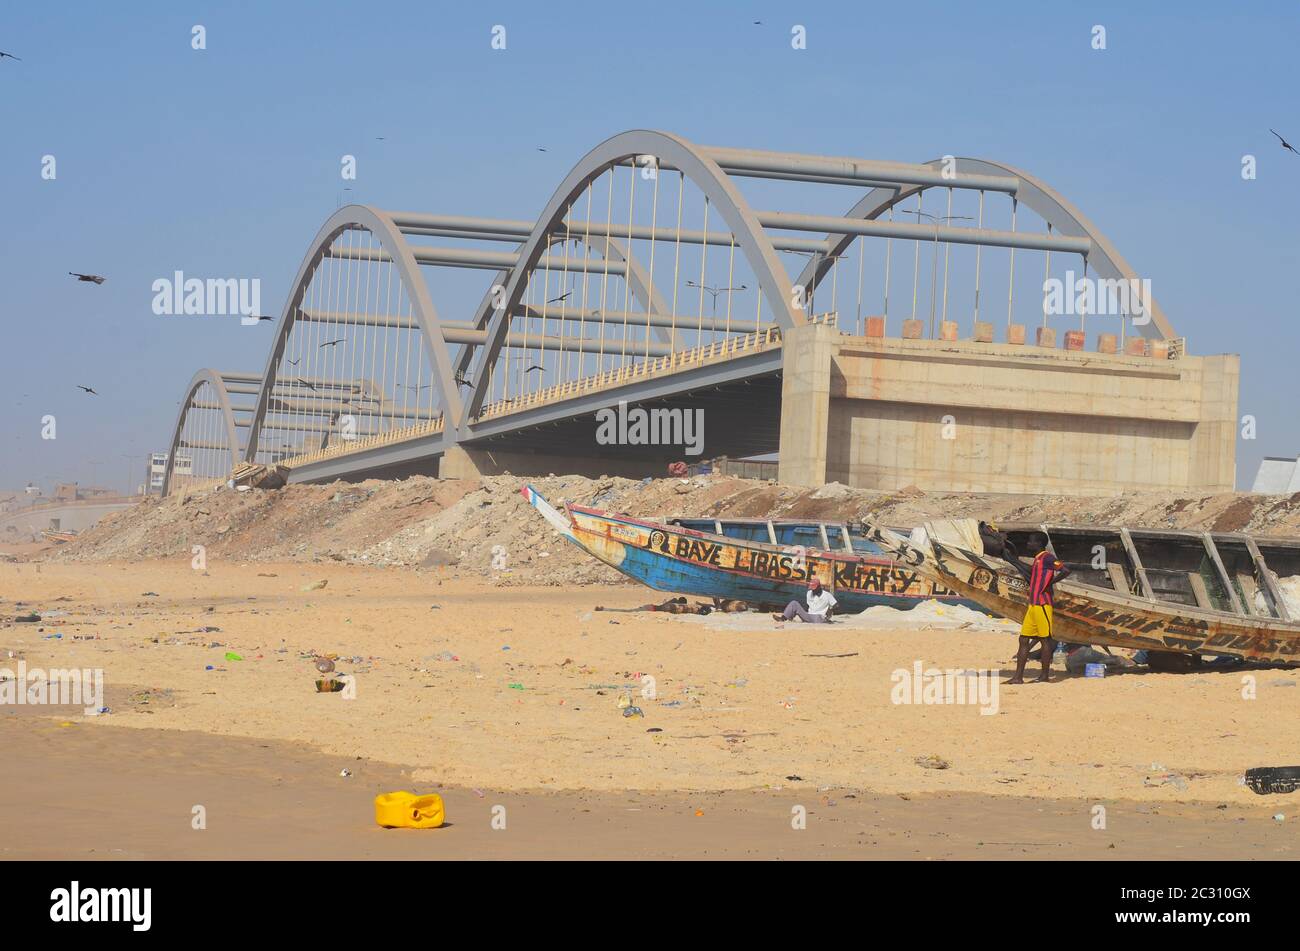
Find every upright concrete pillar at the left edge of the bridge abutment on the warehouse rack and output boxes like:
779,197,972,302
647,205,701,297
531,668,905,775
777,323,840,486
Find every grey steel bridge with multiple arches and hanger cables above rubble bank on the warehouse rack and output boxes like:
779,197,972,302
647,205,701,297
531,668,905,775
157,130,1174,491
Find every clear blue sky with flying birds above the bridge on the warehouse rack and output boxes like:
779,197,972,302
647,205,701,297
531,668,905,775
0,0,1300,487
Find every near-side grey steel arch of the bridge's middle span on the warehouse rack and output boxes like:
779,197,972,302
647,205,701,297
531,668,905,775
244,205,462,463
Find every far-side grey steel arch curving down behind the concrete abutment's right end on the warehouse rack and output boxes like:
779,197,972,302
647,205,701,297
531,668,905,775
796,159,1177,339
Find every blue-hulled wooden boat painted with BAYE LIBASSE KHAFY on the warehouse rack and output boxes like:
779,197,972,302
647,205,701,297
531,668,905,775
521,486,983,613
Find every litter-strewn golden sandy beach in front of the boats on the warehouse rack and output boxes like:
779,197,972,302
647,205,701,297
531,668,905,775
0,560,1300,856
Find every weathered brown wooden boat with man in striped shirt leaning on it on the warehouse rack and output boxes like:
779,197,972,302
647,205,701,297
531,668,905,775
865,520,1300,664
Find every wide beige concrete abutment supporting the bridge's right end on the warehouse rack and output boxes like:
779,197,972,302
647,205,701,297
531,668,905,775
780,326,1239,495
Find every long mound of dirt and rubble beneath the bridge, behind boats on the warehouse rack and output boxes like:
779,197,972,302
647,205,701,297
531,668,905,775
46,476,1300,585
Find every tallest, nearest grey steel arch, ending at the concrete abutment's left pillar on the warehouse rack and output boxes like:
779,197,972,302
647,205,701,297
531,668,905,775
458,130,806,426
